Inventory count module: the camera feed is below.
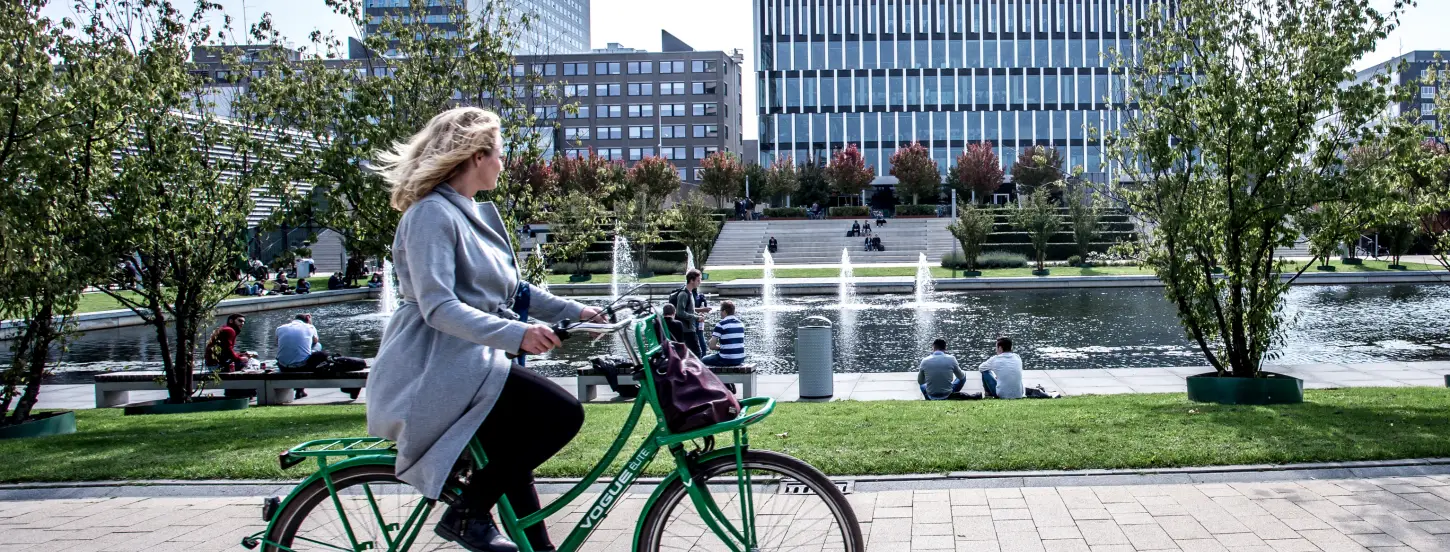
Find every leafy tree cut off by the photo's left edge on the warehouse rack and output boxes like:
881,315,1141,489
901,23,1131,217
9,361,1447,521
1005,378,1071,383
0,0,126,427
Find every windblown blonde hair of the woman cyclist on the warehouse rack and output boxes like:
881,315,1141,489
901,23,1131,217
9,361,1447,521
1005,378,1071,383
377,107,499,212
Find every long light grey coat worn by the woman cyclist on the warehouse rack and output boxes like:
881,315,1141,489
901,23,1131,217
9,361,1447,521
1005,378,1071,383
367,184,584,498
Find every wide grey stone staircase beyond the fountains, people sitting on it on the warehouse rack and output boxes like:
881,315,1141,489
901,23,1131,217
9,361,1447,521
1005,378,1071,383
709,219,954,267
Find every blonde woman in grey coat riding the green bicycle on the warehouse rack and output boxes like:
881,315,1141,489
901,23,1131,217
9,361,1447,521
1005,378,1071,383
367,107,599,552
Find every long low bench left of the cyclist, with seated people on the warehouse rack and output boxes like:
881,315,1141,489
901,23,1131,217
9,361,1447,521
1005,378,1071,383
96,369,368,409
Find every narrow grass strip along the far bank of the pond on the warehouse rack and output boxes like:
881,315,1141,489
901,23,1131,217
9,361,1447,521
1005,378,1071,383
548,261,1441,284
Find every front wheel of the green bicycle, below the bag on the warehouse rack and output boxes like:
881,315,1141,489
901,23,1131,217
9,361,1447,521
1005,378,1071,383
638,451,866,552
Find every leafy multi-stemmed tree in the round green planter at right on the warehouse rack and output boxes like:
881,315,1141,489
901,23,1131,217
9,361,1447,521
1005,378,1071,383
1106,0,1404,377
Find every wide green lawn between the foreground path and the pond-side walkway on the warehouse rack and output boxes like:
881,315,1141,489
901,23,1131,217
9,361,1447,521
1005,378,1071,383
0,388,1450,482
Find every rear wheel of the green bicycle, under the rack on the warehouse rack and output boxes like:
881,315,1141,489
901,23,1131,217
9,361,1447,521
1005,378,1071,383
262,465,450,552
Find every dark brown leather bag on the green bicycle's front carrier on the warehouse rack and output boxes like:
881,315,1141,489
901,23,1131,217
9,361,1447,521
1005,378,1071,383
651,337,740,433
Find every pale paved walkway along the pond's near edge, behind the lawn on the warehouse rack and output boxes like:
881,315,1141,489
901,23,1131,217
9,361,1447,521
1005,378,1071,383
31,362,1450,410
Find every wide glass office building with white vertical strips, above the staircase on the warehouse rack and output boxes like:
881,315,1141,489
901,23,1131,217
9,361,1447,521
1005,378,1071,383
754,0,1164,184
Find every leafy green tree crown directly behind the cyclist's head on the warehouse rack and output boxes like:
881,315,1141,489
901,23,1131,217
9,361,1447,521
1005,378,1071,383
239,0,539,255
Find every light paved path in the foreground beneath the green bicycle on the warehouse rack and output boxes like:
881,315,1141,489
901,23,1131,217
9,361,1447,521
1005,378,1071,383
8,467,1450,552
